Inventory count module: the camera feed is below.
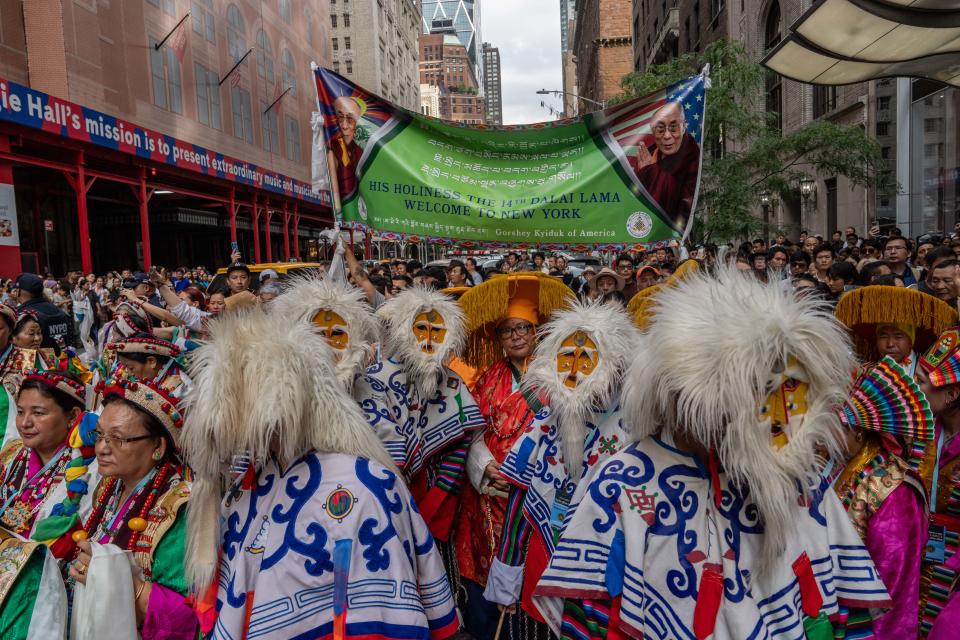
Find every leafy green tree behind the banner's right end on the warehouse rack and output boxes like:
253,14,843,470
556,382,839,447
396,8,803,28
610,40,890,242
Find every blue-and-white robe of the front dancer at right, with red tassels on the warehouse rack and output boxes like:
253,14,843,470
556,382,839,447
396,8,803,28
534,438,890,640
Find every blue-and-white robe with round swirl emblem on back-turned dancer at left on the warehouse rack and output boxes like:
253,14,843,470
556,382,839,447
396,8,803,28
211,453,459,640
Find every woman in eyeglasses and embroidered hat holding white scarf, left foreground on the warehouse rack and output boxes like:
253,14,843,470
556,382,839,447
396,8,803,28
54,379,197,640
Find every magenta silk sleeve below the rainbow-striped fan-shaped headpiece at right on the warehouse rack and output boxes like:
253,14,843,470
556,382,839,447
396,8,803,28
866,483,927,640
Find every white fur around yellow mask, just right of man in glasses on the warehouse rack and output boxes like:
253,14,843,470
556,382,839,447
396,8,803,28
523,302,640,478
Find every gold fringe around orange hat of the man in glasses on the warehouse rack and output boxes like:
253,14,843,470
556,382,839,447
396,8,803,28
459,271,574,373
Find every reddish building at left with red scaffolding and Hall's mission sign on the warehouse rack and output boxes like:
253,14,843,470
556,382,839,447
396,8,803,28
0,0,331,275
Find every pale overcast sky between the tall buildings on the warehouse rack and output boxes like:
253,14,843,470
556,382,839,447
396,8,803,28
478,0,563,124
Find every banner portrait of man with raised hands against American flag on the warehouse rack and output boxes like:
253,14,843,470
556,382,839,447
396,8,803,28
629,102,700,229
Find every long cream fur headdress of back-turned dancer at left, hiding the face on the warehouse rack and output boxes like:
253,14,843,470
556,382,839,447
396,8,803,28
180,307,393,590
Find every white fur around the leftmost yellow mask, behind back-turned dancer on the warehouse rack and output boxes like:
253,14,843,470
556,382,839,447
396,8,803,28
270,276,380,390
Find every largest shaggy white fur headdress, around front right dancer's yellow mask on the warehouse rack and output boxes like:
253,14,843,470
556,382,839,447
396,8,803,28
623,267,854,561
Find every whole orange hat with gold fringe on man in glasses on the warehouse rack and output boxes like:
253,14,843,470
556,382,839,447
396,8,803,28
460,271,574,371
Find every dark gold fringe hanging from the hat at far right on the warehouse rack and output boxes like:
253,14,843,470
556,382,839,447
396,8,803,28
834,285,957,362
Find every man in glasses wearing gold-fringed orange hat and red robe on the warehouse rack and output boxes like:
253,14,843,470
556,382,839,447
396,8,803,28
454,272,573,640
